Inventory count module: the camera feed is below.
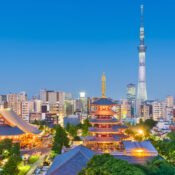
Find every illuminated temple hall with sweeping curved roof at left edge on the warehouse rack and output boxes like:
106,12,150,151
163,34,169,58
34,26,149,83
0,109,41,148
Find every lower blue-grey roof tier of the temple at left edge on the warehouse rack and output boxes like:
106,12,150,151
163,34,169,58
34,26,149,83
0,126,24,136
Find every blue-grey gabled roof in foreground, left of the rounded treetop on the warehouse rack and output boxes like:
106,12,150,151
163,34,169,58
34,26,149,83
47,146,95,175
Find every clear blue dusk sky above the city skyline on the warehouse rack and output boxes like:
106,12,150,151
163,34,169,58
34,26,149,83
0,0,175,99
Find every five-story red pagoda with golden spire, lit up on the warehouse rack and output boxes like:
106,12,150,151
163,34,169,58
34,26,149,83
84,74,126,153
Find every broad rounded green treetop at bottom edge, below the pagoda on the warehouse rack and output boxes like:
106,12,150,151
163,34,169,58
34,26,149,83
79,154,145,175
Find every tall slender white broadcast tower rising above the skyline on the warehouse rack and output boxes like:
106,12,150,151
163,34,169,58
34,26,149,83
137,5,147,114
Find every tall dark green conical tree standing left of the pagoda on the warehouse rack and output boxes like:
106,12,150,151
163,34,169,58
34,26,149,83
52,125,69,154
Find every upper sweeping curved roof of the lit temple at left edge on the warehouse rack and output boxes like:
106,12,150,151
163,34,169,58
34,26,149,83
0,109,41,134
